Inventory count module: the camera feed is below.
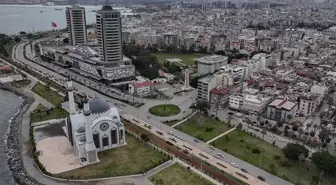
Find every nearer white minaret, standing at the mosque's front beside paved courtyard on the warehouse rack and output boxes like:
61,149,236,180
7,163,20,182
83,98,98,164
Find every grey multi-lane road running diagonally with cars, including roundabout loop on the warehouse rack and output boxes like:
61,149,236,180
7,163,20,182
15,43,291,185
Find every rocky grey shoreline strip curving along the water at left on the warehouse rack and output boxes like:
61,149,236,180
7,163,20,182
0,85,42,185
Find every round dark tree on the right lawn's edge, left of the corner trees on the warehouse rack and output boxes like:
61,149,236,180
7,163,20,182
282,143,309,160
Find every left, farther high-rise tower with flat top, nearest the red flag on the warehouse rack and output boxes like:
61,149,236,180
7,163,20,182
66,6,87,46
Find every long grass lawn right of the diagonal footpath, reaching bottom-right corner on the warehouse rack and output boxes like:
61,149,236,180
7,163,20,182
215,130,336,185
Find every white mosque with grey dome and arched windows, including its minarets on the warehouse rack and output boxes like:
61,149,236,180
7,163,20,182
63,80,126,166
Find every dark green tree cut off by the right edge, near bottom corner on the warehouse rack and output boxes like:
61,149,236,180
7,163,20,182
311,151,336,174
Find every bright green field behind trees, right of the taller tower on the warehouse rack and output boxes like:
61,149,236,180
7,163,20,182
152,53,203,66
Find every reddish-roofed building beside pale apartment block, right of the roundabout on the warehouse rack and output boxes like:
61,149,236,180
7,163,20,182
210,87,230,107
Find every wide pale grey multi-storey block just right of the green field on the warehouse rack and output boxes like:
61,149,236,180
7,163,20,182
196,55,228,76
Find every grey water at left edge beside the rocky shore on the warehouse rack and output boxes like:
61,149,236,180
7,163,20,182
0,89,24,185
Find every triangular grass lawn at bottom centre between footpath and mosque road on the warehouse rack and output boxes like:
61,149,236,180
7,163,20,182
150,163,212,185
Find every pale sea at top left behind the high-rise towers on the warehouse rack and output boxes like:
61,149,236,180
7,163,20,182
0,5,101,35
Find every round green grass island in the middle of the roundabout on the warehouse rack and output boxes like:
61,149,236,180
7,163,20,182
149,104,181,117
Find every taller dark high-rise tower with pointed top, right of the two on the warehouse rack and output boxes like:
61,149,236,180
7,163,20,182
96,5,123,67
